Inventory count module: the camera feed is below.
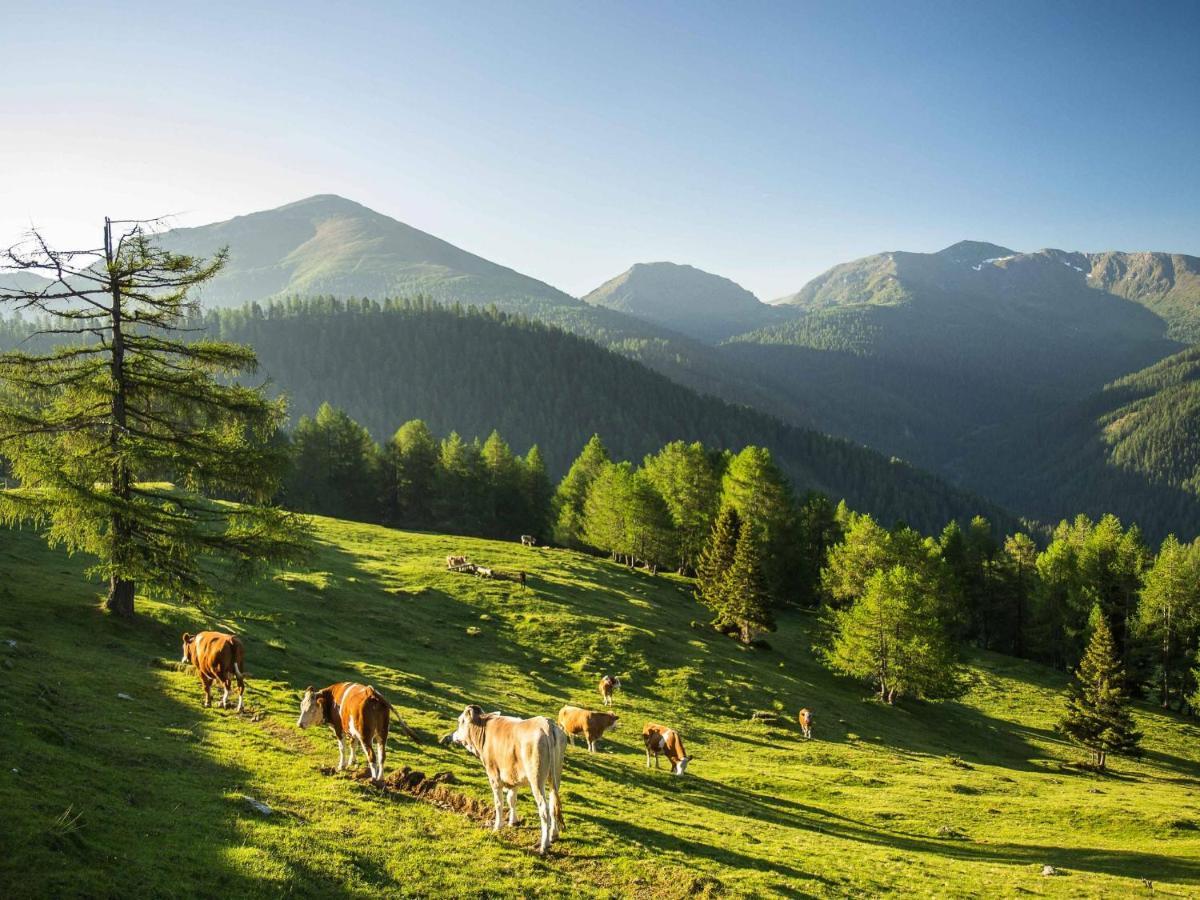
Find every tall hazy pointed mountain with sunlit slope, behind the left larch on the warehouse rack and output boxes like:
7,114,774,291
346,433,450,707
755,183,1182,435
158,194,581,307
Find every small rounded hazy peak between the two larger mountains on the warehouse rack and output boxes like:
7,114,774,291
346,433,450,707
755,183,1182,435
583,263,787,341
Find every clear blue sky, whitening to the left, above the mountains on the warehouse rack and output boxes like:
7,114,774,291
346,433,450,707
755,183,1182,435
0,0,1200,300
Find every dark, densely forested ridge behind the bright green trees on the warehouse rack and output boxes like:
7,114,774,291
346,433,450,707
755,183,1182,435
210,299,1012,529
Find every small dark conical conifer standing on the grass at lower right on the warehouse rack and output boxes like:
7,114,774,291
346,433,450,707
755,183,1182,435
1058,605,1141,772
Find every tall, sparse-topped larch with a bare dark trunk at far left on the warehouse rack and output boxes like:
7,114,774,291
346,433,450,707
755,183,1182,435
0,218,305,617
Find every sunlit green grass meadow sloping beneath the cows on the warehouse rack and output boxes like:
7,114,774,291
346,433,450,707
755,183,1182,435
0,520,1200,898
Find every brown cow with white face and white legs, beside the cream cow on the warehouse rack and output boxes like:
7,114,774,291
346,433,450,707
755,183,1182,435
296,682,419,781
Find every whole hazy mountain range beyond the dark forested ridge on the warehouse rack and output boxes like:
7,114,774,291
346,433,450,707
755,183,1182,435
4,194,1200,534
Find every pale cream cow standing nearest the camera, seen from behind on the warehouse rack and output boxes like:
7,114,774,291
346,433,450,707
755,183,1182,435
454,704,566,853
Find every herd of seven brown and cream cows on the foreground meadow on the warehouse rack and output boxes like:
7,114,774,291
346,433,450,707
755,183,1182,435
175,631,812,853
